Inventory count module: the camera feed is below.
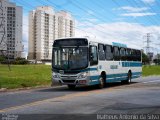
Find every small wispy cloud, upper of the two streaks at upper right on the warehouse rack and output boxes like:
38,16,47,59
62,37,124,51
118,6,149,12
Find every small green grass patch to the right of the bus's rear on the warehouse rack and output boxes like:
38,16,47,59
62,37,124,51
142,65,160,76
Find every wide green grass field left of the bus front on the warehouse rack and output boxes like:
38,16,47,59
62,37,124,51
0,65,51,89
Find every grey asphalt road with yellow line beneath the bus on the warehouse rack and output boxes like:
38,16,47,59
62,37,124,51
0,76,160,120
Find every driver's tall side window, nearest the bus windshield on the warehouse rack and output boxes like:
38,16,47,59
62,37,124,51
89,46,98,65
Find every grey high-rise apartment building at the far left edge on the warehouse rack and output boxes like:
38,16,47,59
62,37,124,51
0,0,23,59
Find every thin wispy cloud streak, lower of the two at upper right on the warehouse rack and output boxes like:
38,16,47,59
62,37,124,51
121,12,157,17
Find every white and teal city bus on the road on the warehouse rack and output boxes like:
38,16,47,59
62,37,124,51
52,38,142,88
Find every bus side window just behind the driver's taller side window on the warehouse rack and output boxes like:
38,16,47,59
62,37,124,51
98,44,105,60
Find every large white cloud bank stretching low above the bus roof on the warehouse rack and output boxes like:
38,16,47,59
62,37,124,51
75,22,160,49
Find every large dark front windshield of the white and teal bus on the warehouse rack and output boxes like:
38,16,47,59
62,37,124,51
52,47,88,70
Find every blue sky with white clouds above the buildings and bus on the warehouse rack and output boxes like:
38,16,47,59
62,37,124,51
10,0,160,54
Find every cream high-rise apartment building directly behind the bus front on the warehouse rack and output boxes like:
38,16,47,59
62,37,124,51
28,6,74,61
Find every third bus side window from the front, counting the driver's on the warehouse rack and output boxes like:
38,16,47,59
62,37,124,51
105,45,113,60
